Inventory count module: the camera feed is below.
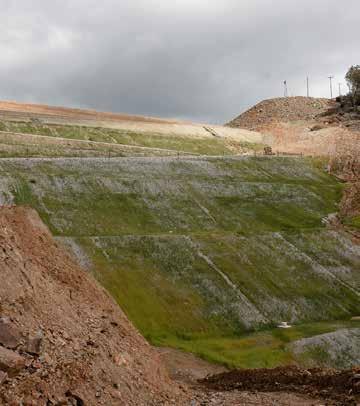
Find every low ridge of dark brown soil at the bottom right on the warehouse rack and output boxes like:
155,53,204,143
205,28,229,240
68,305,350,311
200,366,360,405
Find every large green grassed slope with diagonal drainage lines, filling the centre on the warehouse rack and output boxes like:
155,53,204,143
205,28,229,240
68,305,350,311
0,157,360,366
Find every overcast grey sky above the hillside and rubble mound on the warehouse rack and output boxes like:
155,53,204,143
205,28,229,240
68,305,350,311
0,0,360,123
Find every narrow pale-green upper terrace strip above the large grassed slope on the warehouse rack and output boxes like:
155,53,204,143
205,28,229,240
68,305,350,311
0,117,264,157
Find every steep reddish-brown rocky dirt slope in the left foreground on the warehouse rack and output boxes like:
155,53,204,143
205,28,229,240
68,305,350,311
0,207,182,406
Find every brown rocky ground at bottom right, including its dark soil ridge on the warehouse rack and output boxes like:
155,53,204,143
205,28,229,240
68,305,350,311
158,348,360,406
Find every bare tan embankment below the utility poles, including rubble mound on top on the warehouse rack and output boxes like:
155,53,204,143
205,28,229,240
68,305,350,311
227,97,360,157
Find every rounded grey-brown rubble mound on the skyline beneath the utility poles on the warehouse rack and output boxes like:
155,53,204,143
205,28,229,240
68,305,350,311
226,96,332,130
